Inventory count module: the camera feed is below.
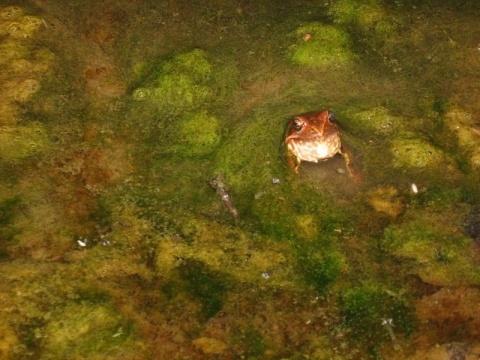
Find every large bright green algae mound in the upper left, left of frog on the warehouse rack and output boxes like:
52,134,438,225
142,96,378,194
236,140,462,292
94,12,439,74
133,49,212,114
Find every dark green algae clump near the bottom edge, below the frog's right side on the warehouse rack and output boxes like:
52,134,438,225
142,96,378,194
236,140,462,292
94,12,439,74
340,284,414,348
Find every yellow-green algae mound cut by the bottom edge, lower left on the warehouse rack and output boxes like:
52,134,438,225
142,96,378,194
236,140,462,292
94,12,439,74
39,302,140,360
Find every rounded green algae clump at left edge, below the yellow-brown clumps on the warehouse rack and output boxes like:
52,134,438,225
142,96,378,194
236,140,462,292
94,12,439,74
0,124,50,163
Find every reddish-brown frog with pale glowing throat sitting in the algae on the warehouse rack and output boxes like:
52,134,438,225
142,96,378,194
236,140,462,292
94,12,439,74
285,109,360,183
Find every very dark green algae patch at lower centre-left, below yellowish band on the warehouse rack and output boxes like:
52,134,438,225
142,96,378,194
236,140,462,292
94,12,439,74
178,259,229,320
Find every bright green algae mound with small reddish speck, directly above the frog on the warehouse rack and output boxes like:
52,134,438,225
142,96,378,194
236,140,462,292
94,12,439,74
291,22,353,67
